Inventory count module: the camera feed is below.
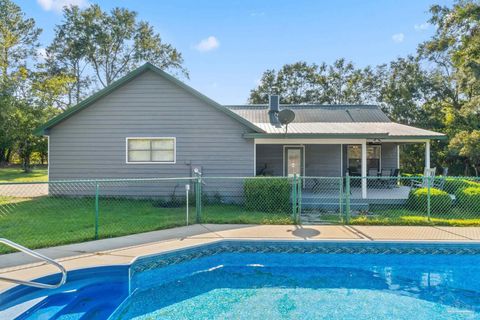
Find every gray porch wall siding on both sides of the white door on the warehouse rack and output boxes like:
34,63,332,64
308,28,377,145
256,144,341,177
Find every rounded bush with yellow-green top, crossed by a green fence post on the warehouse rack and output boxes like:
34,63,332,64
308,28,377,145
408,188,452,213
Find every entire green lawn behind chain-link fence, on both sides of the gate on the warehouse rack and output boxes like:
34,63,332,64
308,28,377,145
0,192,480,254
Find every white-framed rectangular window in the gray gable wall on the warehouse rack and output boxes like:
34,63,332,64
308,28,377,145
127,137,176,163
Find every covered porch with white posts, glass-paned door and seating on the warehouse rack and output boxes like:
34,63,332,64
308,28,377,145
254,138,430,201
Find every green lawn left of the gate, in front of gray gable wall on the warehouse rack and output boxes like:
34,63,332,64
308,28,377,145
0,196,293,253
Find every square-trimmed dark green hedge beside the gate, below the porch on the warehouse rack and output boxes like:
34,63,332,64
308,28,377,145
243,177,291,213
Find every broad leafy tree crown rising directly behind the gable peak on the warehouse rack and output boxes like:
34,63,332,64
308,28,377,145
45,5,187,96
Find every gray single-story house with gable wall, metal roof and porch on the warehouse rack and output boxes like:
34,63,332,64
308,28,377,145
36,63,445,197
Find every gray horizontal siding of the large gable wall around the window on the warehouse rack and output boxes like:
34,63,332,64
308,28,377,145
49,71,254,181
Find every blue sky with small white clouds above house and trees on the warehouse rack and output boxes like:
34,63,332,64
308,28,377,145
14,0,452,104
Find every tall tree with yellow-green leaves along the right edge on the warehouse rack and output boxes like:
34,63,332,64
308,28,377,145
419,1,480,173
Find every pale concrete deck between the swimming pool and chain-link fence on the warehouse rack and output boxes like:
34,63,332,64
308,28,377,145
0,224,480,292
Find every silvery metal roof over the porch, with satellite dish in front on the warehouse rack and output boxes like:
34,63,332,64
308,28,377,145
228,105,446,139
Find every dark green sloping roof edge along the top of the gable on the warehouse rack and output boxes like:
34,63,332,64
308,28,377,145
33,62,265,135
